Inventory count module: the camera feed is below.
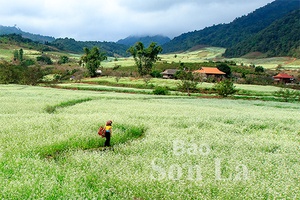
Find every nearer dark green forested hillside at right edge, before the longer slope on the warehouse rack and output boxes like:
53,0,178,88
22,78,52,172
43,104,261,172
224,10,300,58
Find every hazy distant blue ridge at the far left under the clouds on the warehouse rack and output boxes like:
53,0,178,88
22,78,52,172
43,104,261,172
0,25,55,43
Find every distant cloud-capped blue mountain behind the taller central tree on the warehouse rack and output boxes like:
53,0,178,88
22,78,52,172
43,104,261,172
117,35,171,47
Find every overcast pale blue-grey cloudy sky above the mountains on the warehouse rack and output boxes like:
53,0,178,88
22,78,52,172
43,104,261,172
0,0,274,42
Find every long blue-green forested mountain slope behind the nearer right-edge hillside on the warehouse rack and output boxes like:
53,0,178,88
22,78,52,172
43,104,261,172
163,0,300,57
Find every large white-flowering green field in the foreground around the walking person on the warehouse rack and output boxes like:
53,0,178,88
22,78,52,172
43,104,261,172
0,85,300,199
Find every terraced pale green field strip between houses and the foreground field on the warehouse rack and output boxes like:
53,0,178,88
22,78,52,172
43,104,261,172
78,76,290,101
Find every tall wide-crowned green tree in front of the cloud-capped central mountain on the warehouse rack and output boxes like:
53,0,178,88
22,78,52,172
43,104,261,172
127,42,162,76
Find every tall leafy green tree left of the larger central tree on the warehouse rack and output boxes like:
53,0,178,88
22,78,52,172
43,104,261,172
80,47,107,77
